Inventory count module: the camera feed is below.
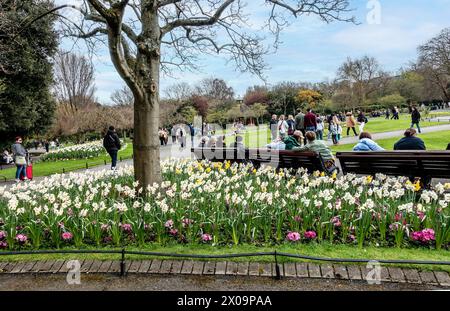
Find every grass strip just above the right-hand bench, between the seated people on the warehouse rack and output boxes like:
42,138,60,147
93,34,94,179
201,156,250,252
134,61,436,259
331,131,450,152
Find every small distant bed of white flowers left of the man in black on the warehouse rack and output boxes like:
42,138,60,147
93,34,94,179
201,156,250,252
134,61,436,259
39,141,106,162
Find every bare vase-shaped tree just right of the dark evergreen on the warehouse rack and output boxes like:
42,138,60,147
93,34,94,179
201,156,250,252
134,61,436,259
54,51,95,111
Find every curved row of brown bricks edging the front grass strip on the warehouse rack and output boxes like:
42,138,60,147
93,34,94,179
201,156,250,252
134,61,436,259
0,259,450,287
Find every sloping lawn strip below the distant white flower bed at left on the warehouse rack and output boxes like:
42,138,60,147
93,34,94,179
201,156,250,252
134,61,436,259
0,142,133,180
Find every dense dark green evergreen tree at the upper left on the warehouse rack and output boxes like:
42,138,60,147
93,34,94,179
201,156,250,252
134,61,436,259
0,0,58,143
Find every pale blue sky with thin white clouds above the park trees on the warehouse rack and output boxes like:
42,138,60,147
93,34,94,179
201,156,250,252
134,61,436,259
56,0,450,104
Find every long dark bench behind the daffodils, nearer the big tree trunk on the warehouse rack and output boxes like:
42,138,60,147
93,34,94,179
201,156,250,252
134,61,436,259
191,147,325,173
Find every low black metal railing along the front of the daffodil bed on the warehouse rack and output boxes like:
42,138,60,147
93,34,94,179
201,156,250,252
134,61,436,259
0,248,450,280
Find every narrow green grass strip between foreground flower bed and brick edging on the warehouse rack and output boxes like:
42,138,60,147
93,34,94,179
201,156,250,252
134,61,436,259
0,242,450,271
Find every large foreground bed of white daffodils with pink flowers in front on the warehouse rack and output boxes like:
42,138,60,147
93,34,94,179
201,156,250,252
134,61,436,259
0,160,450,249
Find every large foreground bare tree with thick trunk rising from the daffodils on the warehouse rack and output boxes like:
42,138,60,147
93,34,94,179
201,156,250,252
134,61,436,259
44,0,354,189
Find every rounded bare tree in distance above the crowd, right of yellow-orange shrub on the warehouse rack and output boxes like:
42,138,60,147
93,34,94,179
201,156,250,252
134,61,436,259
338,56,388,106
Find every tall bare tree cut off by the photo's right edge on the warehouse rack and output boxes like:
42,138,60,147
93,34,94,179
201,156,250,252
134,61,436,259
417,28,450,102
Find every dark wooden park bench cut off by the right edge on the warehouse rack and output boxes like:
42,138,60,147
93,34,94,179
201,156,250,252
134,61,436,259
336,151,450,187
